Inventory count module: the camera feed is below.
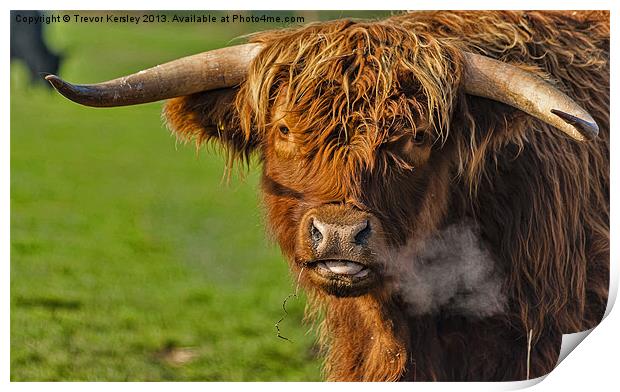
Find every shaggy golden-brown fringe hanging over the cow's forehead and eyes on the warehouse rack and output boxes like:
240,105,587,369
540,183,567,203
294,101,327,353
237,20,461,171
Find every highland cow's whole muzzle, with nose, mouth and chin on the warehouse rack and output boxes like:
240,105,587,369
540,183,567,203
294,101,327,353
296,204,383,296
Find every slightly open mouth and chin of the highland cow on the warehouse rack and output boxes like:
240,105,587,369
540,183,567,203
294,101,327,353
303,259,378,297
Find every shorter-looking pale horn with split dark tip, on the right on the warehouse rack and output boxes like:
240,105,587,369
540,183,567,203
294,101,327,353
462,52,598,141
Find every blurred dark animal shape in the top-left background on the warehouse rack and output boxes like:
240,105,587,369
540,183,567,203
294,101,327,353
11,11,62,87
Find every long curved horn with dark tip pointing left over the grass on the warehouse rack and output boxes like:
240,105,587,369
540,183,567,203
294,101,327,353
44,44,261,107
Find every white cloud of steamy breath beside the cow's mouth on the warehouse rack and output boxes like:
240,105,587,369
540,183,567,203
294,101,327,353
386,222,507,317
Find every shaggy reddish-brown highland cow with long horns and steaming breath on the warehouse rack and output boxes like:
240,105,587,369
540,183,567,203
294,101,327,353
47,11,609,381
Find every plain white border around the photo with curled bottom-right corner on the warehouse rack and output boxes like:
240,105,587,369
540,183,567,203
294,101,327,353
0,0,620,391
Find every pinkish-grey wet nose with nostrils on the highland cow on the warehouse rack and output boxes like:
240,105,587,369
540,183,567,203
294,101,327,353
309,217,372,248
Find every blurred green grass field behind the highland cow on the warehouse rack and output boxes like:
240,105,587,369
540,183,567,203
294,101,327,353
10,11,390,381
